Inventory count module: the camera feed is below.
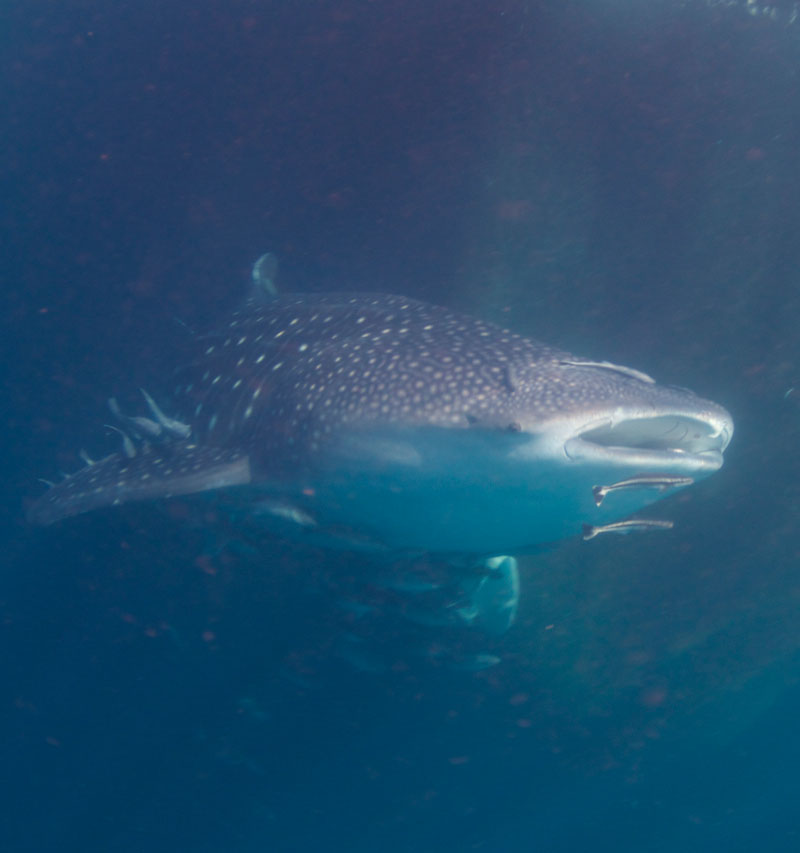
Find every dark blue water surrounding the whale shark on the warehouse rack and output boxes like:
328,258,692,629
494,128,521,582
0,0,800,853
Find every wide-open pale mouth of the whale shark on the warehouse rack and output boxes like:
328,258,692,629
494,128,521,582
564,411,733,470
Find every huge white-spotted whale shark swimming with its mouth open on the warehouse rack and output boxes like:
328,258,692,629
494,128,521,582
29,265,733,557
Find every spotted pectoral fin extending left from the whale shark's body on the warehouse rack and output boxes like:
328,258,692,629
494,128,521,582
28,441,251,524
